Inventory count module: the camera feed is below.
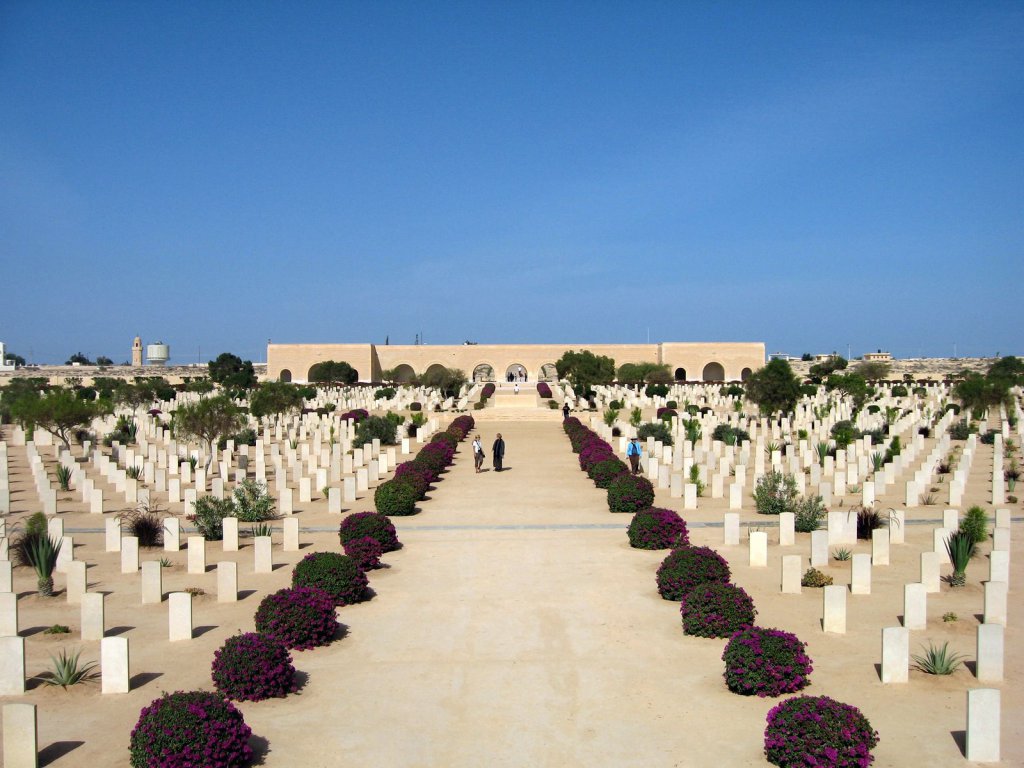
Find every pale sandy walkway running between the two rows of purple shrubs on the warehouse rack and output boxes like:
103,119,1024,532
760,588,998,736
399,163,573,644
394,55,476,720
246,422,764,768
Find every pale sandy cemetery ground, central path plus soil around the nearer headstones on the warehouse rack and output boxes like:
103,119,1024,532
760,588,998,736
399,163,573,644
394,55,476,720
0,412,1024,768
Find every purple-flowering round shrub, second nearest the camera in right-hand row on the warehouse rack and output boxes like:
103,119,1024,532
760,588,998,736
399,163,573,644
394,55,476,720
722,627,814,696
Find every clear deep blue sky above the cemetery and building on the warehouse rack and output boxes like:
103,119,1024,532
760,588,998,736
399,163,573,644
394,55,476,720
0,0,1024,362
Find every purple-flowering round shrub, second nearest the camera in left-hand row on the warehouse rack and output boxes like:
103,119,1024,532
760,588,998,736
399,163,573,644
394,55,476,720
211,632,295,701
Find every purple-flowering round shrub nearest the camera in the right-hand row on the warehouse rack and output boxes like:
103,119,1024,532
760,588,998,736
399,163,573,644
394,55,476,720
765,696,879,768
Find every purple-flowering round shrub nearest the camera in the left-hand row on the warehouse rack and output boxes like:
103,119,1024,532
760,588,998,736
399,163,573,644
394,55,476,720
128,690,253,768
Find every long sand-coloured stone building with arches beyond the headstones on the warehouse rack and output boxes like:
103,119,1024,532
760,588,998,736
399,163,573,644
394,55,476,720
266,342,765,382
